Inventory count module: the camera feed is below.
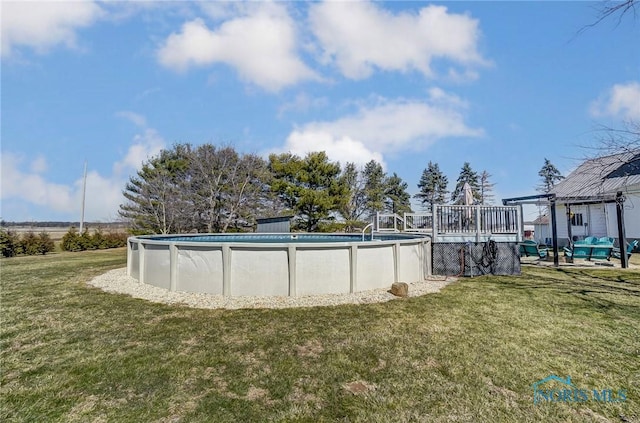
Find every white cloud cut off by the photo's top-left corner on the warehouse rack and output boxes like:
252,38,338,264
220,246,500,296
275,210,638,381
1,1,103,57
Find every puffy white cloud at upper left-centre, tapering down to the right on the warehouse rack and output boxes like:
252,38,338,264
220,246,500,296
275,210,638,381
158,3,319,91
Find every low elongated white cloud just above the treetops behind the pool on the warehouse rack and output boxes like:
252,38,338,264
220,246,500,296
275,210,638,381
281,88,484,168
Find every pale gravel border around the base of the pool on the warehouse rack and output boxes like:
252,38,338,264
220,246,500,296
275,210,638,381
87,268,457,309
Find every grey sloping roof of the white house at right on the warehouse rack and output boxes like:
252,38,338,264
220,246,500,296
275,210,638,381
550,149,640,199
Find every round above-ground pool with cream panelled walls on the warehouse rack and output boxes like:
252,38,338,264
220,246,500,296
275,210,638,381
127,233,431,296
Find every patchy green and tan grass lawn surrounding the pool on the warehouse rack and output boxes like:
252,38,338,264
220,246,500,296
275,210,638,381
0,249,640,423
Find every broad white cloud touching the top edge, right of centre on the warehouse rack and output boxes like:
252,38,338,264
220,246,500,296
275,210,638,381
309,2,487,79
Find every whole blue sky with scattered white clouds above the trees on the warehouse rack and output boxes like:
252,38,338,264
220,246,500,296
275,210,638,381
0,1,640,221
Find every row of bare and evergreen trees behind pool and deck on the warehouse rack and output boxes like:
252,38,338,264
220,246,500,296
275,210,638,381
119,144,568,234
